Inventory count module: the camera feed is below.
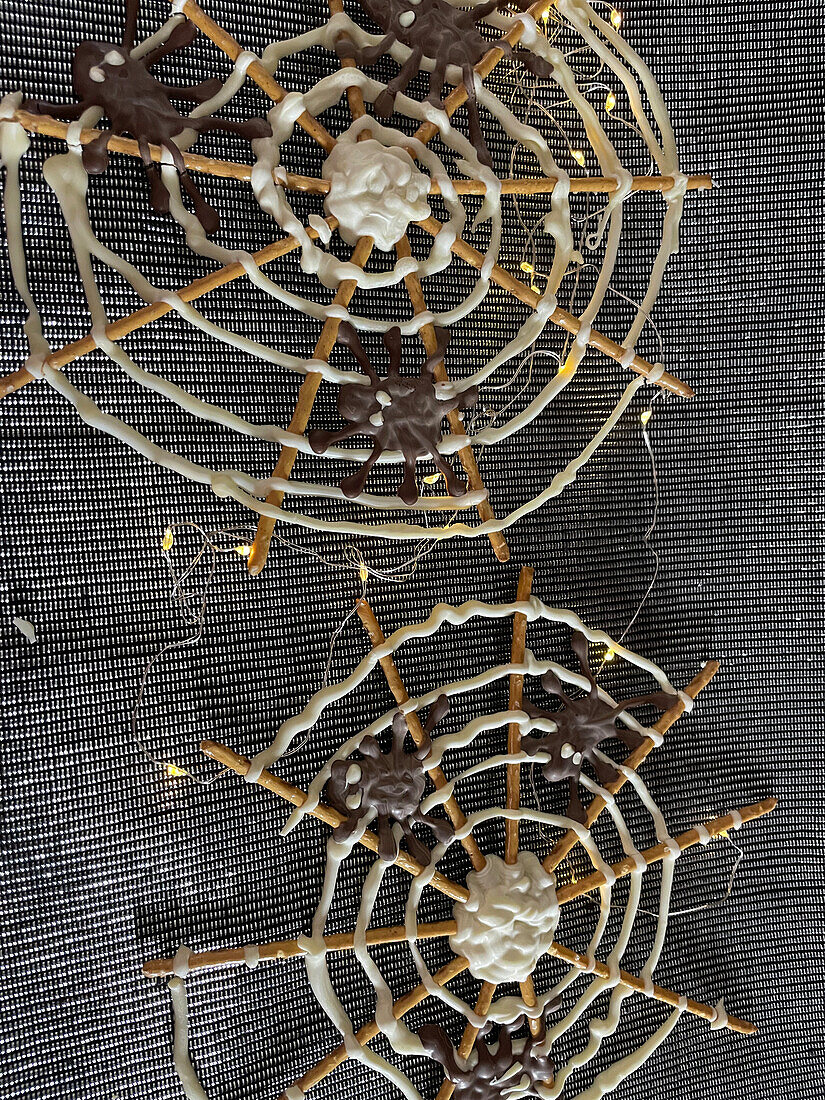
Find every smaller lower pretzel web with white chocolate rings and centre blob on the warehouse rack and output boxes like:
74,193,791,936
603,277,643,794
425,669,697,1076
144,569,776,1100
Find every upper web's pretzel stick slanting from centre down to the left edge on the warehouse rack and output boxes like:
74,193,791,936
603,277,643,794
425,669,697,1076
0,218,338,398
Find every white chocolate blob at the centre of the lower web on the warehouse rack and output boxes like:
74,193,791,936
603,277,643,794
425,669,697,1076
450,851,560,985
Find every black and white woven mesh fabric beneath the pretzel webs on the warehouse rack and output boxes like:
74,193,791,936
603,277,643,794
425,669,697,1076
0,0,825,1100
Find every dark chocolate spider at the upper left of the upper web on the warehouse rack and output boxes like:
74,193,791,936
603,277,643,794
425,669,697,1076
26,0,272,233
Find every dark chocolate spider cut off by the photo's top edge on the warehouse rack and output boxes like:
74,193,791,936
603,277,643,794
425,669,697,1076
343,0,552,165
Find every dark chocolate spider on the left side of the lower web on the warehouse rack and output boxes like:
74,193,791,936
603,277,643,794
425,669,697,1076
327,695,453,867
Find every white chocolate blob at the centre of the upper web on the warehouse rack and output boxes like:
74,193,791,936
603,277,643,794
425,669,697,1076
322,138,430,252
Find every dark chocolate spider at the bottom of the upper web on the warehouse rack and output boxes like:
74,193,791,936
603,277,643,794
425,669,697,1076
307,322,477,505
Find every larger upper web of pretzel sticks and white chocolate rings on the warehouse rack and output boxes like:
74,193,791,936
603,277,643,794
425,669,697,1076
0,0,710,572
